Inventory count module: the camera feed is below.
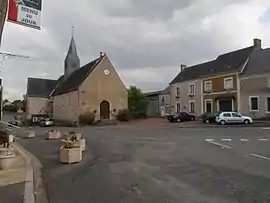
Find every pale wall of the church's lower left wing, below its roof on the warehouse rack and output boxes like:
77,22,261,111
26,97,49,120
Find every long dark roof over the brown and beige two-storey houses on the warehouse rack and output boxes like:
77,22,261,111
170,46,254,85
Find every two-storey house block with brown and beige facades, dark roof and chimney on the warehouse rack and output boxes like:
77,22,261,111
170,39,261,115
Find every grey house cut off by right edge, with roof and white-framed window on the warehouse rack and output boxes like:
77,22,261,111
239,48,270,119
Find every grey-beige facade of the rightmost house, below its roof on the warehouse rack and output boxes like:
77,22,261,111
240,74,270,118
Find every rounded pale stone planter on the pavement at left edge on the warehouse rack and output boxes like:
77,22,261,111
0,150,16,170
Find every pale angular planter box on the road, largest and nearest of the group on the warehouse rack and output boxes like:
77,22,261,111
60,147,82,164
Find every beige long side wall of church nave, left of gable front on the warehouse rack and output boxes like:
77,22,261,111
53,91,79,121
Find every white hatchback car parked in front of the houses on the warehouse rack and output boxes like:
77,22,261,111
216,112,253,125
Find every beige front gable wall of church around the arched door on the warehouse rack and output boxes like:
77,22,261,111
79,56,128,119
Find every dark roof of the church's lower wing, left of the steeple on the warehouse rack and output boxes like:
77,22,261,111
26,78,58,97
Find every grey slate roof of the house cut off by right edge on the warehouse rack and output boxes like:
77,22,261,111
241,48,270,76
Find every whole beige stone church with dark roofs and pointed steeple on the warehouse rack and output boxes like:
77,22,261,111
25,36,127,123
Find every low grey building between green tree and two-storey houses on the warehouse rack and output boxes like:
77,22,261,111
145,87,170,117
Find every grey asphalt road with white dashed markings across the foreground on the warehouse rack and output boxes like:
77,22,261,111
17,126,270,203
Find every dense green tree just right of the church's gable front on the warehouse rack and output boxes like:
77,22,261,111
128,86,148,118
